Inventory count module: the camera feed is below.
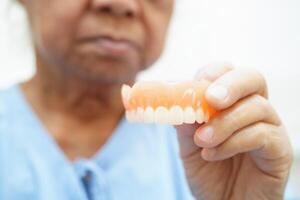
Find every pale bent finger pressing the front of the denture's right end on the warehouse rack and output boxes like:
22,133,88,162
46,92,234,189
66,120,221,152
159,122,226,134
205,69,267,110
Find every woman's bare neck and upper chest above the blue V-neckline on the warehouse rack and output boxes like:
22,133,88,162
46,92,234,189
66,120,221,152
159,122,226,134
21,61,133,160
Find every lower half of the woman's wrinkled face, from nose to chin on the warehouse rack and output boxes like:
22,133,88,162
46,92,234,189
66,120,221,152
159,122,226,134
23,0,174,83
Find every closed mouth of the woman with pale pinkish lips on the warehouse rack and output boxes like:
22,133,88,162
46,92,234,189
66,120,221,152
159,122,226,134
78,36,139,58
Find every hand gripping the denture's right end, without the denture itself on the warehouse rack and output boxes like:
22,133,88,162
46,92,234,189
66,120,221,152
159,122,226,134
177,64,292,200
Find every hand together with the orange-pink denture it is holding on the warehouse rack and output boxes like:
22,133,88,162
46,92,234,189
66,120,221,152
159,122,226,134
123,64,292,200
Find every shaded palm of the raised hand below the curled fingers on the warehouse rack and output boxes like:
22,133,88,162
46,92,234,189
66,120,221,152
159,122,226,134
178,124,289,199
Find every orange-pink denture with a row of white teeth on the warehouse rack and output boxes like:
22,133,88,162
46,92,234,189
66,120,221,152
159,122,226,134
122,80,217,125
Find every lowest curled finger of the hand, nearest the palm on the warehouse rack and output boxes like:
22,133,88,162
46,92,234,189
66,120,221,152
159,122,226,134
201,122,290,161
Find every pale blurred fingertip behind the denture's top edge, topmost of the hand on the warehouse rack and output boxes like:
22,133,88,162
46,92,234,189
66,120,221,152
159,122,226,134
195,62,234,82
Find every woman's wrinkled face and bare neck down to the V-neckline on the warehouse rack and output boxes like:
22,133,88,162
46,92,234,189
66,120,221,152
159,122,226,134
20,0,174,160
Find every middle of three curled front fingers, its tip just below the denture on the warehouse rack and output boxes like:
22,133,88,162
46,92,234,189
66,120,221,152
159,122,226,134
194,95,281,148
